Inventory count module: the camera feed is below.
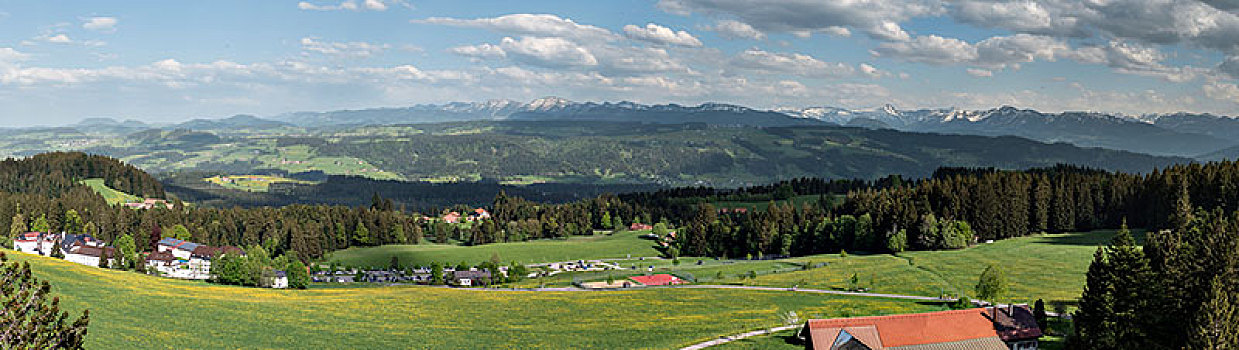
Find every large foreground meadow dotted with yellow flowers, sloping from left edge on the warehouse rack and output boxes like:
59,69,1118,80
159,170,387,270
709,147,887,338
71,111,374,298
4,251,942,349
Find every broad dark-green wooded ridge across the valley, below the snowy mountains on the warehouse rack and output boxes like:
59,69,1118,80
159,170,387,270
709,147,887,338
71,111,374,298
313,122,1192,186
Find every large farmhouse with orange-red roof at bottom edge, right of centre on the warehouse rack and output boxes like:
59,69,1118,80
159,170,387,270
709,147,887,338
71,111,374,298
799,307,1041,350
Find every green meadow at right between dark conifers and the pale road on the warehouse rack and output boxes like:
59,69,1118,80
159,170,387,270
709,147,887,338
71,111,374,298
737,231,1144,303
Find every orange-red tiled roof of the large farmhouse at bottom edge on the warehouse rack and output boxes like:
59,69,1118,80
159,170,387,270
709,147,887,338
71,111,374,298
807,309,1020,349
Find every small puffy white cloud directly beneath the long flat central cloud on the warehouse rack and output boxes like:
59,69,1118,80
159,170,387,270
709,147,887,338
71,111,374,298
499,36,598,68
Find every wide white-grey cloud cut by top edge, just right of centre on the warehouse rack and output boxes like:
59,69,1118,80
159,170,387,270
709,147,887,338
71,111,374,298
658,0,945,40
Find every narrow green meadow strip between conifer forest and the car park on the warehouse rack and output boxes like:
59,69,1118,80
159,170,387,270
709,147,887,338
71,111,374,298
327,231,659,266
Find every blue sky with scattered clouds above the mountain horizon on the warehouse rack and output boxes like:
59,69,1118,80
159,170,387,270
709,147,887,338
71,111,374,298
0,0,1239,127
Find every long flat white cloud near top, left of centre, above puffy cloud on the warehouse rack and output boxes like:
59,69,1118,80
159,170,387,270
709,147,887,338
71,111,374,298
413,14,618,41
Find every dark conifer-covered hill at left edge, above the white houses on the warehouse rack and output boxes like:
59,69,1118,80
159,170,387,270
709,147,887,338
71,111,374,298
0,153,164,197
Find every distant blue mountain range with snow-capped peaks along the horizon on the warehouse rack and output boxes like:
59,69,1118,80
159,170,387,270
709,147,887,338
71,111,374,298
72,97,1239,160
